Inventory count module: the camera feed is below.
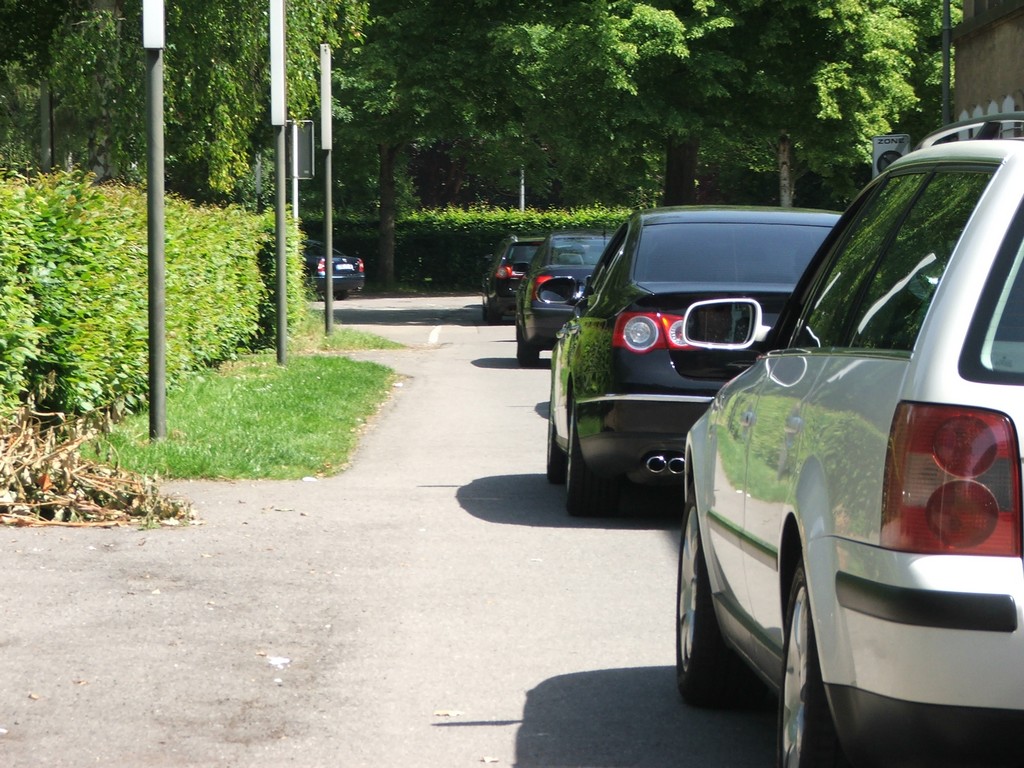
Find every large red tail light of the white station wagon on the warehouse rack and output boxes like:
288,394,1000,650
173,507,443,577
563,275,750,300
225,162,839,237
882,402,1021,557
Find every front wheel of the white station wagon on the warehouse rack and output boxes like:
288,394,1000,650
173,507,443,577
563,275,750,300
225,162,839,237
676,487,766,708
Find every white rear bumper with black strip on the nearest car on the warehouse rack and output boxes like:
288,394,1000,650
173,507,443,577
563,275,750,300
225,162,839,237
805,536,1024,768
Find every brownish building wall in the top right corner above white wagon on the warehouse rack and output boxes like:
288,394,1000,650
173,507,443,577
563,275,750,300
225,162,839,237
953,0,1024,120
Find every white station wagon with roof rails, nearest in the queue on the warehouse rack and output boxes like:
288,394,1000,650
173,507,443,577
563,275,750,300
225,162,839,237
676,117,1024,768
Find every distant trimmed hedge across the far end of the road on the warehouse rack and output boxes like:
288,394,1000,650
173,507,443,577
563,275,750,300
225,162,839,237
334,207,630,291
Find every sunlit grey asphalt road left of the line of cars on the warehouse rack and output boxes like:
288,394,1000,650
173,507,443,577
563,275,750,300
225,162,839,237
0,296,774,768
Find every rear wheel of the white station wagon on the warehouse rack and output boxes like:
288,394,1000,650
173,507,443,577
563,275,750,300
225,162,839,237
778,564,850,768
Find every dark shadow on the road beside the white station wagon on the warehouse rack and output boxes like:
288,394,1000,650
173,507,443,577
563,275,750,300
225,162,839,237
507,667,775,768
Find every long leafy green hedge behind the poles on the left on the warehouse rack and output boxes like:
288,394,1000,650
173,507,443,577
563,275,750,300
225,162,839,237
0,173,306,413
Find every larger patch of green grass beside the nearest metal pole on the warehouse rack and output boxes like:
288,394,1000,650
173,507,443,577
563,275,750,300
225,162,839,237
98,355,394,479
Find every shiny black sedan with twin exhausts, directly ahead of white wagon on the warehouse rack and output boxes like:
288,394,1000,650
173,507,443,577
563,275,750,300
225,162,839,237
547,207,839,515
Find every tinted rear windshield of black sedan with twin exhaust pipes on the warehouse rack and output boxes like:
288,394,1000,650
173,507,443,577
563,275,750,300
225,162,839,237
634,222,831,286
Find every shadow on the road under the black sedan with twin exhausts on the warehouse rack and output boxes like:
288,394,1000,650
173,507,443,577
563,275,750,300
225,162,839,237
456,474,683,531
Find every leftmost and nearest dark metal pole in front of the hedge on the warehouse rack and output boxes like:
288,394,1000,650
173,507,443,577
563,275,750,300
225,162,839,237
145,18,167,440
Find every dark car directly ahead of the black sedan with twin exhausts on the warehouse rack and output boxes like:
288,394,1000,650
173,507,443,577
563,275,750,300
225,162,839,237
515,229,610,367
